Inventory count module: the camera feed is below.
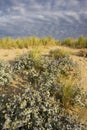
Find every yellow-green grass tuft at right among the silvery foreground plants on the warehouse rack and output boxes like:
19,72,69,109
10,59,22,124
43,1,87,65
56,77,81,109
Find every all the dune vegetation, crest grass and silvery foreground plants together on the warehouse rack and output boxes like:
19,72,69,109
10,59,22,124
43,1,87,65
0,36,87,130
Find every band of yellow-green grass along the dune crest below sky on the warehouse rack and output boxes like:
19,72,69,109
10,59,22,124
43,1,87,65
0,36,87,49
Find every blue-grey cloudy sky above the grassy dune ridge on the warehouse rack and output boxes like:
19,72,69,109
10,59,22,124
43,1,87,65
0,0,87,39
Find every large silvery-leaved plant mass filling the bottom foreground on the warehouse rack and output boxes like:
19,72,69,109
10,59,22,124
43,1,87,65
0,86,87,130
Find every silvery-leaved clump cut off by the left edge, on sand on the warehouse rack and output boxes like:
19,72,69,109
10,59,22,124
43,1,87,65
0,61,12,86
